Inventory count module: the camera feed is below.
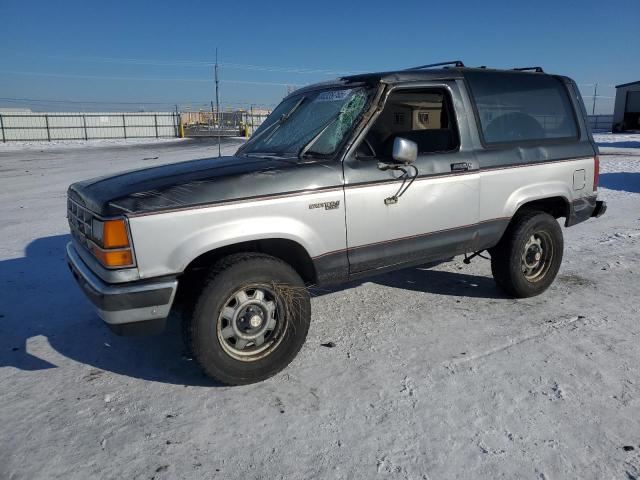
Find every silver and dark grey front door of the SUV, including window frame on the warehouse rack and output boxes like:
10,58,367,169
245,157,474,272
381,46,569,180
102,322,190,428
343,82,479,275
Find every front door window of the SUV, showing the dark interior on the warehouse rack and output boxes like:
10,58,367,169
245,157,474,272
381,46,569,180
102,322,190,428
357,89,460,158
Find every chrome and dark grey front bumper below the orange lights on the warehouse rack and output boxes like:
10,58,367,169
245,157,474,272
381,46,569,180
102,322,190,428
67,243,178,335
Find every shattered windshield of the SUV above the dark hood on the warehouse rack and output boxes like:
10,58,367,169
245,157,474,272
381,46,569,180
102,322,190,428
242,88,370,157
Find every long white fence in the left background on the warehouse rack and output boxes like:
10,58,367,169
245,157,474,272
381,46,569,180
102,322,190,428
0,112,179,142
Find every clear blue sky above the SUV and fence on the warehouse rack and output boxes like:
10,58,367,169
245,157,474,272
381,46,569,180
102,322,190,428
0,0,640,113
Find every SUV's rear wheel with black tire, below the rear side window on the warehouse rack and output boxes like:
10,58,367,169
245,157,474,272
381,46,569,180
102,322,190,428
489,211,564,298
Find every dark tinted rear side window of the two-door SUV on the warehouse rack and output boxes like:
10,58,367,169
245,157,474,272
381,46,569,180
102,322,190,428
466,72,578,145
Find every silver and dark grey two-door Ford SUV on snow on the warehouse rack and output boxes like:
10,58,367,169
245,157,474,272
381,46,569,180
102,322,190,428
67,62,606,384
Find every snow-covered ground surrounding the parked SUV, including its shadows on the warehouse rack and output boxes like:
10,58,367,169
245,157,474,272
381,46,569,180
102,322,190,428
0,135,640,480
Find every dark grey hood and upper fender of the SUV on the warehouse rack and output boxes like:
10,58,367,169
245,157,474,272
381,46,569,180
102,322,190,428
68,156,342,216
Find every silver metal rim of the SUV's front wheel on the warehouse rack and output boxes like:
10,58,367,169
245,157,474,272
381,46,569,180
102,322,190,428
216,285,285,361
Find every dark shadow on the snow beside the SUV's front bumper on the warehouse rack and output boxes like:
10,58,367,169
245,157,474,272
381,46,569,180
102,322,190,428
0,235,218,386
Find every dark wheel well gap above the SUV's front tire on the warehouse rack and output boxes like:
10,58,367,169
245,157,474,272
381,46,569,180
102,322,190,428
182,238,316,284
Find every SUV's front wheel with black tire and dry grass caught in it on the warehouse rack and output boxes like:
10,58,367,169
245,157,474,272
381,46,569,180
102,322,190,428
184,253,311,385
